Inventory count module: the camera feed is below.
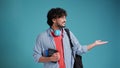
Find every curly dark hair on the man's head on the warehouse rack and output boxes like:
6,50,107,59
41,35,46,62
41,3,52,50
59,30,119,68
47,8,67,27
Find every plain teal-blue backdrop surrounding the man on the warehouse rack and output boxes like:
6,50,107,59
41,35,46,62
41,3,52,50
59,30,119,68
0,0,120,68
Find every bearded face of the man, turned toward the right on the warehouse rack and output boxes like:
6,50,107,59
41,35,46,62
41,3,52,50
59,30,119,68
54,16,66,28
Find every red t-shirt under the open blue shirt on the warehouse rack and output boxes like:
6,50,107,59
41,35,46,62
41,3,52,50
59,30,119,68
52,33,65,68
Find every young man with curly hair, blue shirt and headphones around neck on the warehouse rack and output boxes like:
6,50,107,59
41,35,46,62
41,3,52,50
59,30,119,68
33,8,107,68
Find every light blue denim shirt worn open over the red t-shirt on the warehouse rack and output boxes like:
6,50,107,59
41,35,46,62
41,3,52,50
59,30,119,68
33,28,88,68
